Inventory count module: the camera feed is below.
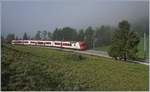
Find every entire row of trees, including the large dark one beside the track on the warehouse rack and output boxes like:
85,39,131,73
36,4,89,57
1,20,148,61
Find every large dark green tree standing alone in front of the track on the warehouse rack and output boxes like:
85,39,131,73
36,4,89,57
108,20,140,61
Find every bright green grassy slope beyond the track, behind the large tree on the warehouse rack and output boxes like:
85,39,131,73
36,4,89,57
95,39,144,59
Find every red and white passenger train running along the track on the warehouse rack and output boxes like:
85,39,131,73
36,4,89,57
12,40,87,50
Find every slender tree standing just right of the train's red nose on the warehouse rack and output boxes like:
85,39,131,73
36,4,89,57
84,27,94,48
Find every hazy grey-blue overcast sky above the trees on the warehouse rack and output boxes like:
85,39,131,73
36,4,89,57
1,0,149,37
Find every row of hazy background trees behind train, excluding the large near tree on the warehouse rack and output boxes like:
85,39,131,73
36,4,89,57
2,25,114,48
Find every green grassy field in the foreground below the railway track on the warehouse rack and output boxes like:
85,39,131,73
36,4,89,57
1,45,149,91
